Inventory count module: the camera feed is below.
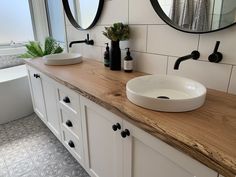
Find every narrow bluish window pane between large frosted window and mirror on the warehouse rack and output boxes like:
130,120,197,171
46,0,65,43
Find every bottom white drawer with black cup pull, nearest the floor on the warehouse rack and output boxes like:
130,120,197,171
62,128,83,164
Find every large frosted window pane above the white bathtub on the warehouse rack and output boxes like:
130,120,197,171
0,0,35,45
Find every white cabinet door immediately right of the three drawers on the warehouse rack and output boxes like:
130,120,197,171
81,97,123,177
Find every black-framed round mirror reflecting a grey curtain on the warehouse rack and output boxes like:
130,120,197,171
150,0,236,34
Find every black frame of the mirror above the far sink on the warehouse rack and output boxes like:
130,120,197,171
62,0,104,30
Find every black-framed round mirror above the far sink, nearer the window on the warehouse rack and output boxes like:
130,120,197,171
62,0,104,29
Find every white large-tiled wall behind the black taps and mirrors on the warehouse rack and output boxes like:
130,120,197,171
66,0,236,94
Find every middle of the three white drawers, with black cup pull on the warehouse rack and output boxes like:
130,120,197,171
60,109,81,139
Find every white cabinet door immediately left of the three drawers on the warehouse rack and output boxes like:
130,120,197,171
42,76,61,139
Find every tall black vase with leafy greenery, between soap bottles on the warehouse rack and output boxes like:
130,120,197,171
103,23,129,70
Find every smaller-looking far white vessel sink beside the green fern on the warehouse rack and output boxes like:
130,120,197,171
43,53,82,65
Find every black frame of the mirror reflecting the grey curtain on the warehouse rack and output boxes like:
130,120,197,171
150,0,236,34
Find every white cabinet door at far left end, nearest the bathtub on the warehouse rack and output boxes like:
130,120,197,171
28,66,47,123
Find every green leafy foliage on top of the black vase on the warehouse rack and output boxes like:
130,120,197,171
103,23,129,41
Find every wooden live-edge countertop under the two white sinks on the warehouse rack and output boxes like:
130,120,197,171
26,58,236,177
